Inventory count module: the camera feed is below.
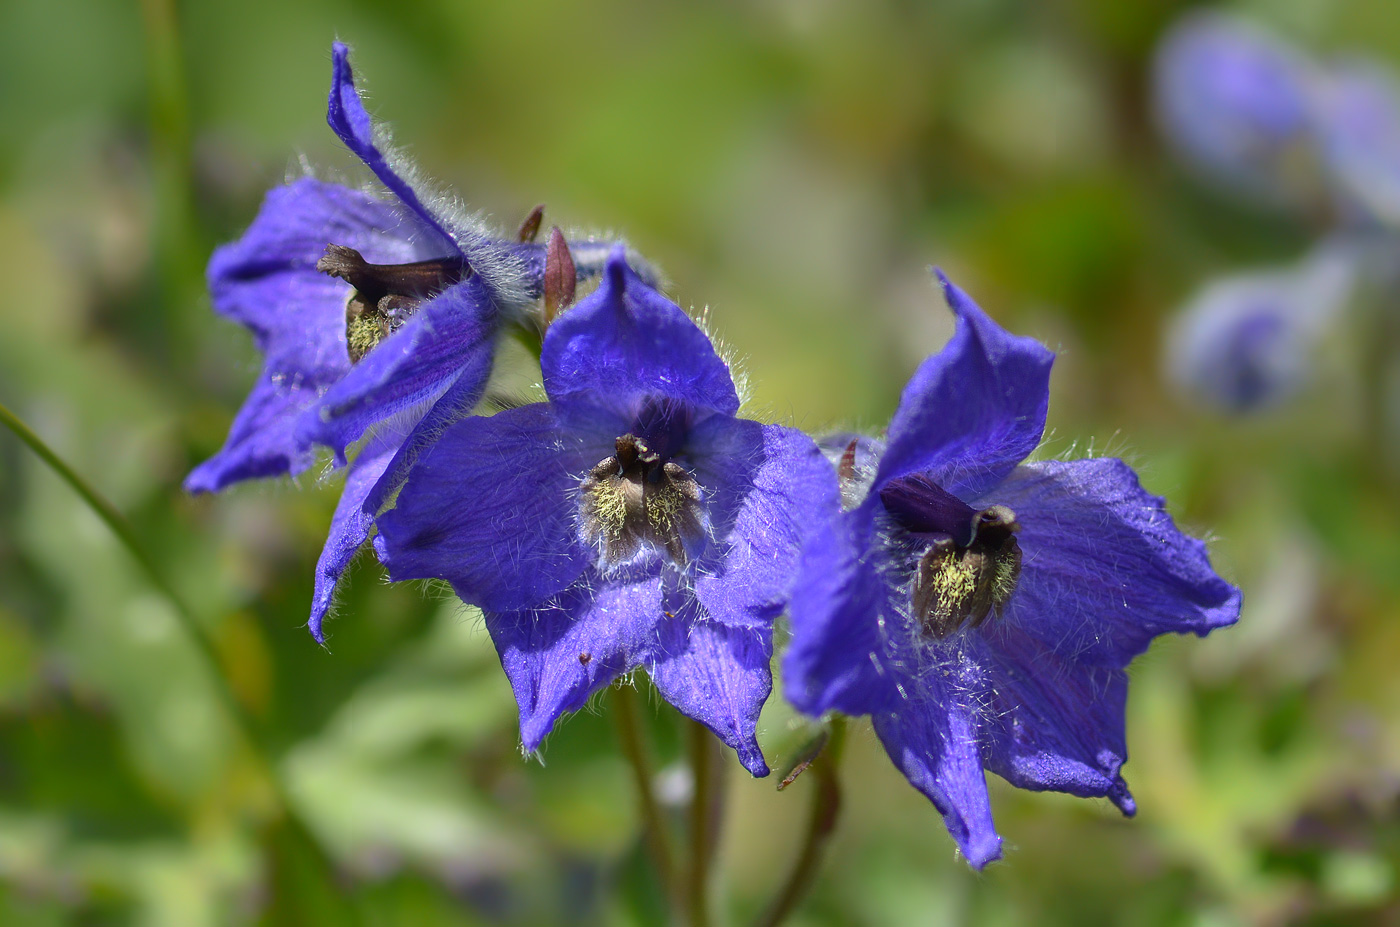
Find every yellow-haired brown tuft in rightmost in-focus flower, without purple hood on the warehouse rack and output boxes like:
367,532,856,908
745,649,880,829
911,506,1021,640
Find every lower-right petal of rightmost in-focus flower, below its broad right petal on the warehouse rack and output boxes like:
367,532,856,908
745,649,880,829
963,632,1135,814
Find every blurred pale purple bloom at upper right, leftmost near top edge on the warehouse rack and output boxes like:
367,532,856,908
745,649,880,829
1154,11,1319,204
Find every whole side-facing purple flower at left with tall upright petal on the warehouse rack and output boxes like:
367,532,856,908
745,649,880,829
185,43,630,640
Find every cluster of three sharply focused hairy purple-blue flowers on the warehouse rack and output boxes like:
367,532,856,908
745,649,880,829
186,45,1239,867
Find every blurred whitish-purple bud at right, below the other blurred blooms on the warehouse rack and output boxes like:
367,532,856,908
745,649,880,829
1166,241,1358,414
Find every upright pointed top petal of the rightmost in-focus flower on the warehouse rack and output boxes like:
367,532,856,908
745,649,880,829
875,272,1054,499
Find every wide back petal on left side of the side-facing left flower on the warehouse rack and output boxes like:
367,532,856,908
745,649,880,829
185,178,430,492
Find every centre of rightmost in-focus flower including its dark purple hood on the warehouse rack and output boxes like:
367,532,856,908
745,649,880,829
881,476,1021,640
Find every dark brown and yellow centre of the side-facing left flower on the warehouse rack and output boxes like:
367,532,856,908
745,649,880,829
316,245,472,364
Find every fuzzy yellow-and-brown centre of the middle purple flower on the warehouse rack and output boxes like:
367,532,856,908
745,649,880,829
581,434,704,566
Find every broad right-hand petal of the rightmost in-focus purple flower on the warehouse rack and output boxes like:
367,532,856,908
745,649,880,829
976,458,1240,668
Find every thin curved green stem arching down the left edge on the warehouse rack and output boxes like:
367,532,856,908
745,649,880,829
0,403,355,924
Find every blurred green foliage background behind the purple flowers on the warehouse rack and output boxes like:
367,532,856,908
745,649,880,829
0,0,1400,927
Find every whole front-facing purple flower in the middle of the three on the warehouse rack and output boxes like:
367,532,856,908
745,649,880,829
375,251,836,776
